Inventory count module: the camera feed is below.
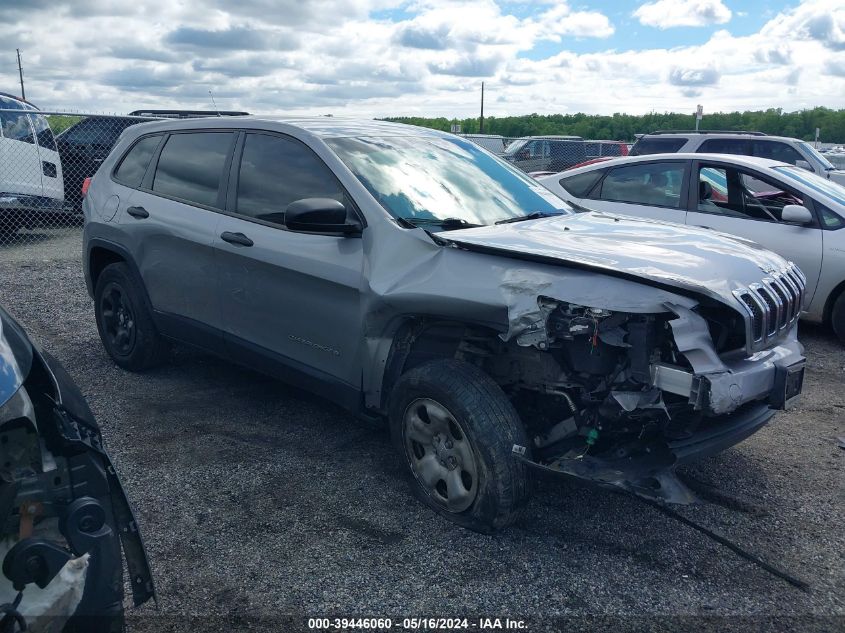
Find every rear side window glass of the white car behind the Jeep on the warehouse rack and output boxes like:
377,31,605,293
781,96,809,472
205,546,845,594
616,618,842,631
598,163,684,209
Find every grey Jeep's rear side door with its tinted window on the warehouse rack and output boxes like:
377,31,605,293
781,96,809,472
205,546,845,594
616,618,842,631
115,130,237,351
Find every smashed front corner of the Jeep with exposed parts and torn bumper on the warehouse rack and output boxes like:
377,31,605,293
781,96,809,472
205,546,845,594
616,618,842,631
465,273,804,503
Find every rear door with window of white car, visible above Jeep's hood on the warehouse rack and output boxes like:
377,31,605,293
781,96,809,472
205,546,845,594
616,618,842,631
583,160,689,224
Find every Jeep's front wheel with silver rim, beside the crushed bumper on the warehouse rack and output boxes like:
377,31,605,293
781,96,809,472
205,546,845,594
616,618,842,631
390,360,531,534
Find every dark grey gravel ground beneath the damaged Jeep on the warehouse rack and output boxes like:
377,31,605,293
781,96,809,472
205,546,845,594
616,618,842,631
0,237,845,631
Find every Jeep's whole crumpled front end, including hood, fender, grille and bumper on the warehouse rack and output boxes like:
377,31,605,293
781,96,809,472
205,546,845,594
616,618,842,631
362,214,805,502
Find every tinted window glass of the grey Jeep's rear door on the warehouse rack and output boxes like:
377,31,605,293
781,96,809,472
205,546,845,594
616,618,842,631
153,132,232,206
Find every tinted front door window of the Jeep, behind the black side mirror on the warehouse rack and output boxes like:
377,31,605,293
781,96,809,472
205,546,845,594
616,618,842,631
237,134,350,224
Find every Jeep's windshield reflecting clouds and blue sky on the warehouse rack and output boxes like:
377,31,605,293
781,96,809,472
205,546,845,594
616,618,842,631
326,136,574,228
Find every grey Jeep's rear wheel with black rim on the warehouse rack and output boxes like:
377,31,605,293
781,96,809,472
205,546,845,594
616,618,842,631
94,263,169,371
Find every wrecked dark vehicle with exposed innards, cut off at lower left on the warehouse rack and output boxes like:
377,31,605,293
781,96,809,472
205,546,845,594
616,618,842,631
0,308,155,633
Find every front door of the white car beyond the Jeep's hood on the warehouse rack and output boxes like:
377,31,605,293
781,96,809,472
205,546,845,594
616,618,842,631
687,161,823,306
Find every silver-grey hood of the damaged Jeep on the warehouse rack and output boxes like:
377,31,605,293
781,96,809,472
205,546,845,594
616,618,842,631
437,212,787,306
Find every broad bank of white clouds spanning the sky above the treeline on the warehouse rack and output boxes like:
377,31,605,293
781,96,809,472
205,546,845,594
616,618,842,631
0,0,845,118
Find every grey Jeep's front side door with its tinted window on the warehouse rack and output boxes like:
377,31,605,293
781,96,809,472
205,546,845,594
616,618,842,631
215,132,364,397
